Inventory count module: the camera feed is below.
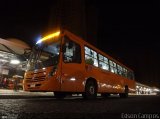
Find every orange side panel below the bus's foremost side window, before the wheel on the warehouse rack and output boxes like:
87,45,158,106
61,63,85,92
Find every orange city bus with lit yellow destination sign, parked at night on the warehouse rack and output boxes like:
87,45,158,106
23,30,135,99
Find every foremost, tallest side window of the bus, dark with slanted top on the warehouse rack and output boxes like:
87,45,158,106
63,37,81,63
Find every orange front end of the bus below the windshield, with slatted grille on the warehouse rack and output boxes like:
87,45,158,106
24,67,61,92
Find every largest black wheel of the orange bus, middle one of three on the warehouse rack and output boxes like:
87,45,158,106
82,80,97,99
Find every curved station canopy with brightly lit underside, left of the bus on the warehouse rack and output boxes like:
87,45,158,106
0,38,30,69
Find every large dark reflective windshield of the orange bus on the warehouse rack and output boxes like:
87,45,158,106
27,41,60,71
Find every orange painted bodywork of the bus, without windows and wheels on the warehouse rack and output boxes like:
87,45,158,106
24,31,135,93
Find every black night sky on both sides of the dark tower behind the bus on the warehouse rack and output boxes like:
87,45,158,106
0,0,160,87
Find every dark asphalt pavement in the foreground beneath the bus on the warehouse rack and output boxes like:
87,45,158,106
0,91,160,119
